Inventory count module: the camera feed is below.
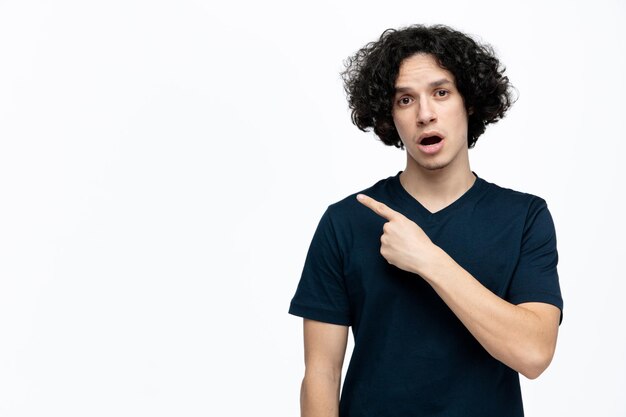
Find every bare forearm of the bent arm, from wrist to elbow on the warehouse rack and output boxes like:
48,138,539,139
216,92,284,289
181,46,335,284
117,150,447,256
421,248,556,378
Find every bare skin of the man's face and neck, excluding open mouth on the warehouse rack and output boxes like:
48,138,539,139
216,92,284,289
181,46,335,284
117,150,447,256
392,54,475,212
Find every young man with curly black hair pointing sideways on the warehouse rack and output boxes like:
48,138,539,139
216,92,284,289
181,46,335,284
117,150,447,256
289,25,563,417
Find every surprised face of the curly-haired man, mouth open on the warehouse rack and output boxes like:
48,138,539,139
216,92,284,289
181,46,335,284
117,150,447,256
392,54,469,172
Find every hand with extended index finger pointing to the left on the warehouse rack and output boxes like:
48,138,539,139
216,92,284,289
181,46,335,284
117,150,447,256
357,194,439,276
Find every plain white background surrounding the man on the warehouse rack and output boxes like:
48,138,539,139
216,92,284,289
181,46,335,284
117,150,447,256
0,0,626,417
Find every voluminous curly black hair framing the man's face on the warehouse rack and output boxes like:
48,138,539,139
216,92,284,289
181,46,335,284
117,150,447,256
341,25,514,149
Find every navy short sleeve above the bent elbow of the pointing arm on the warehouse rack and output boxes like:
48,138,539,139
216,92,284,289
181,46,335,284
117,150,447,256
507,197,563,321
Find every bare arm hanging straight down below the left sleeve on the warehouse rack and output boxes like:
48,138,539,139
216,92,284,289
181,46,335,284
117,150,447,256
300,319,348,417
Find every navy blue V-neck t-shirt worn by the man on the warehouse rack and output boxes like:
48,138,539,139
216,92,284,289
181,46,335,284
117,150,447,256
289,171,563,417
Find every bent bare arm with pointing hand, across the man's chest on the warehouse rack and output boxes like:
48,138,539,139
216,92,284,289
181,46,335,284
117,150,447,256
359,196,561,379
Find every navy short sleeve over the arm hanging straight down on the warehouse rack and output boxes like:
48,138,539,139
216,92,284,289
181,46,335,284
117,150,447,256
289,208,350,326
